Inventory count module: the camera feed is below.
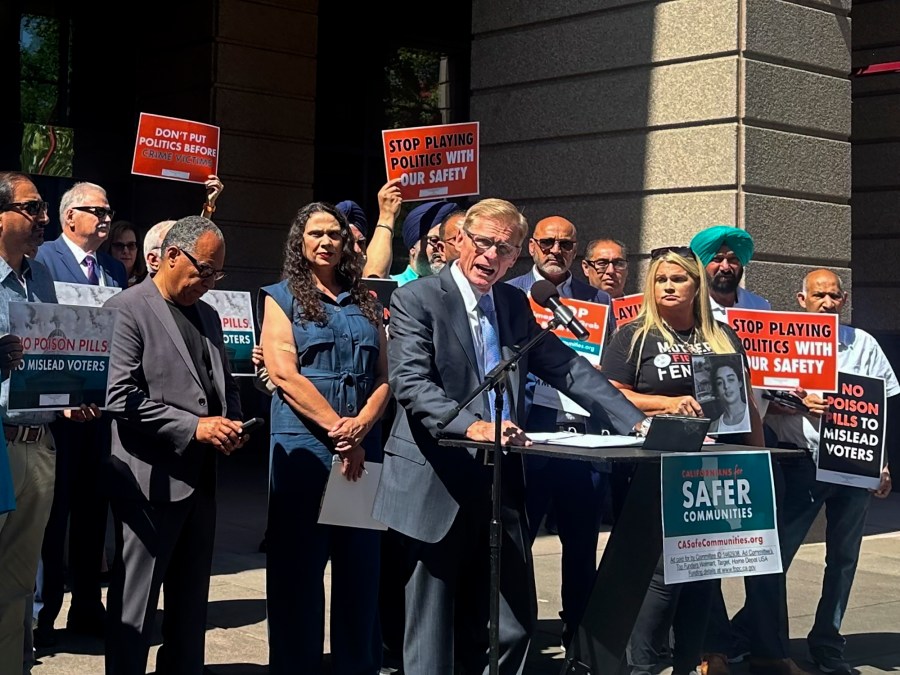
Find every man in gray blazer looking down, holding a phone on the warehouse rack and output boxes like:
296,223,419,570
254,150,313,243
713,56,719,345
105,216,246,675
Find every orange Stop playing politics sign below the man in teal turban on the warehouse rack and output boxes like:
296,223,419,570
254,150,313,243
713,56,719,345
726,307,838,391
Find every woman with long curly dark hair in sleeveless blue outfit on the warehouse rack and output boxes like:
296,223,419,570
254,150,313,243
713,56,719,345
260,202,390,675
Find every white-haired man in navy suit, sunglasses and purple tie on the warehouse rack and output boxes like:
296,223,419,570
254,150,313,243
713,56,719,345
35,183,128,647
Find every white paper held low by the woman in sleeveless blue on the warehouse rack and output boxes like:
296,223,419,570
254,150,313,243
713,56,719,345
318,455,387,530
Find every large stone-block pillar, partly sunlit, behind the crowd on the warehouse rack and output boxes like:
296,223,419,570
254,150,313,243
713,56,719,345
470,0,850,309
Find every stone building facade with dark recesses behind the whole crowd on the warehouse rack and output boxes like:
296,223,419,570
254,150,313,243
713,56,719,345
0,0,900,356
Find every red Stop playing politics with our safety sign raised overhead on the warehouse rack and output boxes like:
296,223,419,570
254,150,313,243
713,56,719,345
381,122,479,202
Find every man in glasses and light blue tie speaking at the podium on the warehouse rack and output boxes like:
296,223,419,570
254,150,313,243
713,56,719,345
373,199,645,675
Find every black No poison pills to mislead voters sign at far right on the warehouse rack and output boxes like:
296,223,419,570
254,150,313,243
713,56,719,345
816,373,887,490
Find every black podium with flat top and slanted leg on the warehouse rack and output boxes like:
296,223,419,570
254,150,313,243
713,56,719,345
440,438,804,675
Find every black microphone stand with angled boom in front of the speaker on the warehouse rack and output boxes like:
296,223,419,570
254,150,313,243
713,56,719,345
437,318,559,675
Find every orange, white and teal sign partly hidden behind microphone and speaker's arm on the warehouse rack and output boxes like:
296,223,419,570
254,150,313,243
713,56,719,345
528,295,609,417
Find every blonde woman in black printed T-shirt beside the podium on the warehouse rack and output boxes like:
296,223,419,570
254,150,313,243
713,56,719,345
603,246,763,675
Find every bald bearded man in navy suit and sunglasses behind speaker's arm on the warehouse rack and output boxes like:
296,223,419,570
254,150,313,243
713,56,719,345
507,216,612,647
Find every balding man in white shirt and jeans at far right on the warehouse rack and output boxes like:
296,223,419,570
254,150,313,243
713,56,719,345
734,269,900,675
